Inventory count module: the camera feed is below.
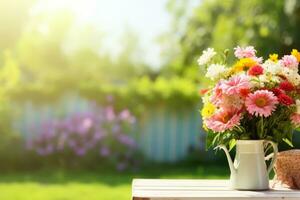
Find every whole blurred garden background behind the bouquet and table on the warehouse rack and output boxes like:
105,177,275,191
0,0,300,200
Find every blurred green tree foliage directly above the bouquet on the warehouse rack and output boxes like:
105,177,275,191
168,0,300,74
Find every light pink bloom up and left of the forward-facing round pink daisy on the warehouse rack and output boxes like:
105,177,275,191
220,75,251,95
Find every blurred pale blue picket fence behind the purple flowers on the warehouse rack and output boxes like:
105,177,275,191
13,94,204,162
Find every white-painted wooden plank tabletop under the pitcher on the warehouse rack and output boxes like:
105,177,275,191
132,179,300,200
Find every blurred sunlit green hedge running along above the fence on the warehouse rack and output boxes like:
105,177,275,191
8,77,199,107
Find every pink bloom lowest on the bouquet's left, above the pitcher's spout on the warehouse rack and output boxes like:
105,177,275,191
204,109,242,132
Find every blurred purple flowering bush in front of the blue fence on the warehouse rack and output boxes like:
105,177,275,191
26,101,137,171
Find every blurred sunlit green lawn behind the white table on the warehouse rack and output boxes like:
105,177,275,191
0,166,229,200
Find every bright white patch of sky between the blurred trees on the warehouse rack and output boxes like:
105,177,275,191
32,0,170,67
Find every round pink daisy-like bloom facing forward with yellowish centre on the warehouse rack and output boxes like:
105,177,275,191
245,90,278,117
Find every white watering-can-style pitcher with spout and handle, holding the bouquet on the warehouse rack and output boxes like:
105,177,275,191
219,140,278,190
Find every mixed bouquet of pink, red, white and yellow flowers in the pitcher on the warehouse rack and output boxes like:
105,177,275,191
198,46,300,149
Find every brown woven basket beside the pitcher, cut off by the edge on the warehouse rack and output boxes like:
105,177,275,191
273,150,300,189
